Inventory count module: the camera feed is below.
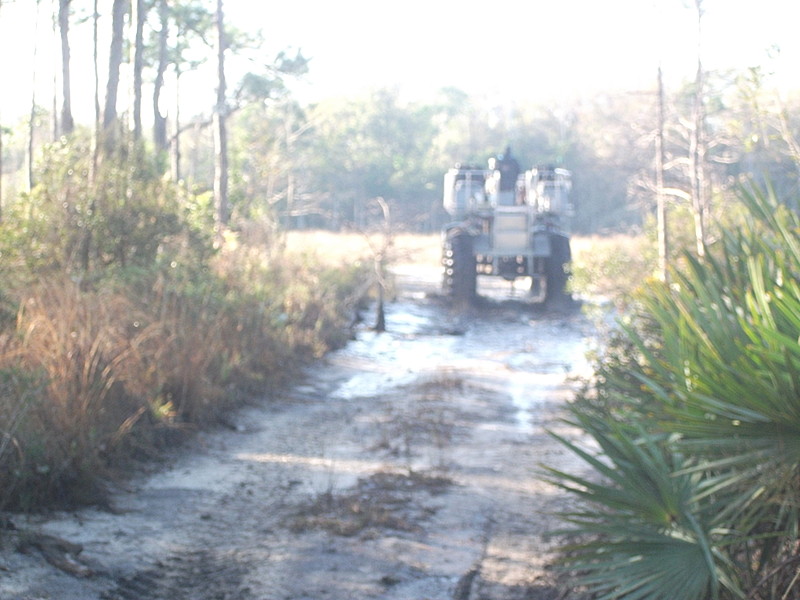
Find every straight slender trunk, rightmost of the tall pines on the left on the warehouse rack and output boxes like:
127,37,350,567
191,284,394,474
214,0,230,230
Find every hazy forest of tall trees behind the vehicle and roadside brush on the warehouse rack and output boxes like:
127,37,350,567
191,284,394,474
0,0,797,237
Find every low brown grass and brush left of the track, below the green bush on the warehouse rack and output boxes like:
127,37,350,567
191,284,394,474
0,239,363,510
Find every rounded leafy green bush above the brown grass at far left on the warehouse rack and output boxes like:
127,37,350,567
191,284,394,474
0,135,213,281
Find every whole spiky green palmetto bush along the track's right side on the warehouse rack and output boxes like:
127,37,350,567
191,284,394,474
549,190,800,600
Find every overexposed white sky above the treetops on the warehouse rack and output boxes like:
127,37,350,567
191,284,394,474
0,0,800,123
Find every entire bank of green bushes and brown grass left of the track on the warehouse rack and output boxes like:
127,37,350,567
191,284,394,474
0,146,367,510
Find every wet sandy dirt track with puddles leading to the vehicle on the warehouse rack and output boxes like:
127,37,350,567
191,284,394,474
0,272,592,600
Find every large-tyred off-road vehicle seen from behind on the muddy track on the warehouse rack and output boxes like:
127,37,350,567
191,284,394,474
442,149,572,303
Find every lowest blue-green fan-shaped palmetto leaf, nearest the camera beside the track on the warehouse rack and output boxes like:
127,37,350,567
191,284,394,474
547,422,738,600
